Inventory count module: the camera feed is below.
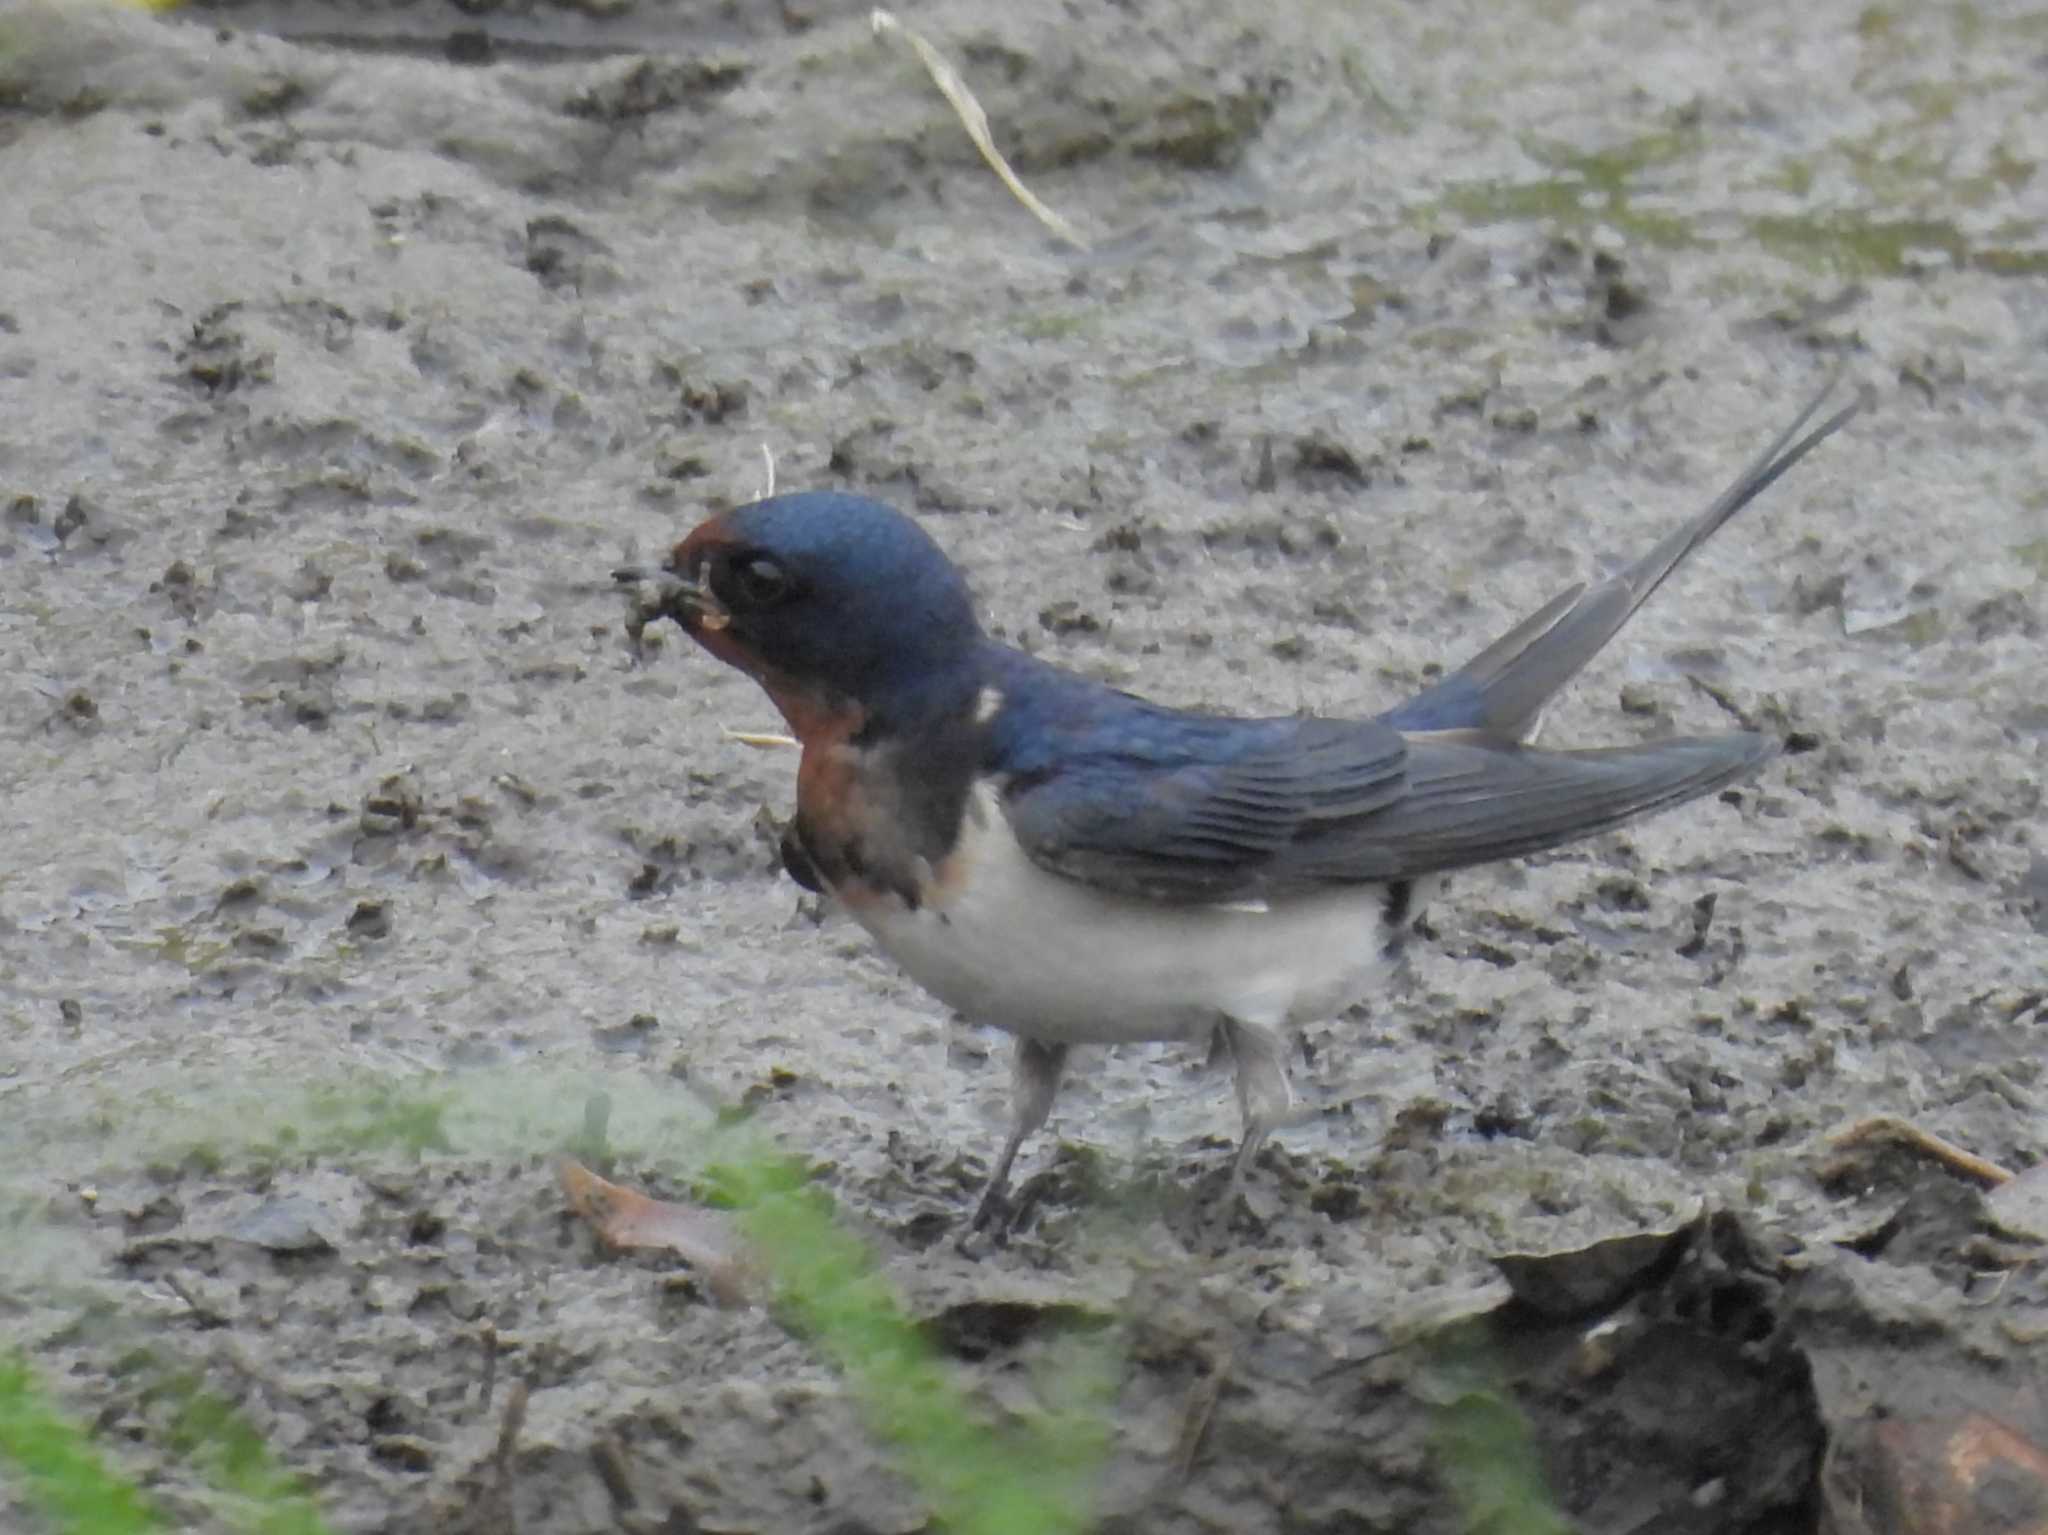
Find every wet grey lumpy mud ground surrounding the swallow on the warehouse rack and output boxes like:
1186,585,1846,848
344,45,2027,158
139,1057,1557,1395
0,0,2048,1533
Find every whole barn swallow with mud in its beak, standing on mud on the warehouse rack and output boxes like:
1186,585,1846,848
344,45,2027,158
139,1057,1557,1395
614,391,1858,1252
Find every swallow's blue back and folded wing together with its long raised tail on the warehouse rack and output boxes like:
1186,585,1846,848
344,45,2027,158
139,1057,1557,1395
981,393,1858,903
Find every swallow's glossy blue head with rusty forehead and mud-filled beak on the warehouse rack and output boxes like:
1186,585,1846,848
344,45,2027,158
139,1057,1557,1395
614,491,981,735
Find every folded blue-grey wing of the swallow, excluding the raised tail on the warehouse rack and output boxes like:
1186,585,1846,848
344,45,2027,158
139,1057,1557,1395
983,657,1776,903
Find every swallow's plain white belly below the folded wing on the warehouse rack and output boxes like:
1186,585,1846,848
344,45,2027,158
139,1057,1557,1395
831,790,1386,1044
